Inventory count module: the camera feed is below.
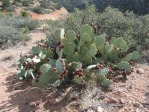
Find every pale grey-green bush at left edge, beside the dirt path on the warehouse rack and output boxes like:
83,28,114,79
0,13,39,47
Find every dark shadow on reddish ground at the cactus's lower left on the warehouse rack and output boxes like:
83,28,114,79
0,75,70,112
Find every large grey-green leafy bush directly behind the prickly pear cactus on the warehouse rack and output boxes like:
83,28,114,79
65,6,149,50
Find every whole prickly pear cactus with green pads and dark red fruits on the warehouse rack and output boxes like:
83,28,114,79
17,24,139,87
